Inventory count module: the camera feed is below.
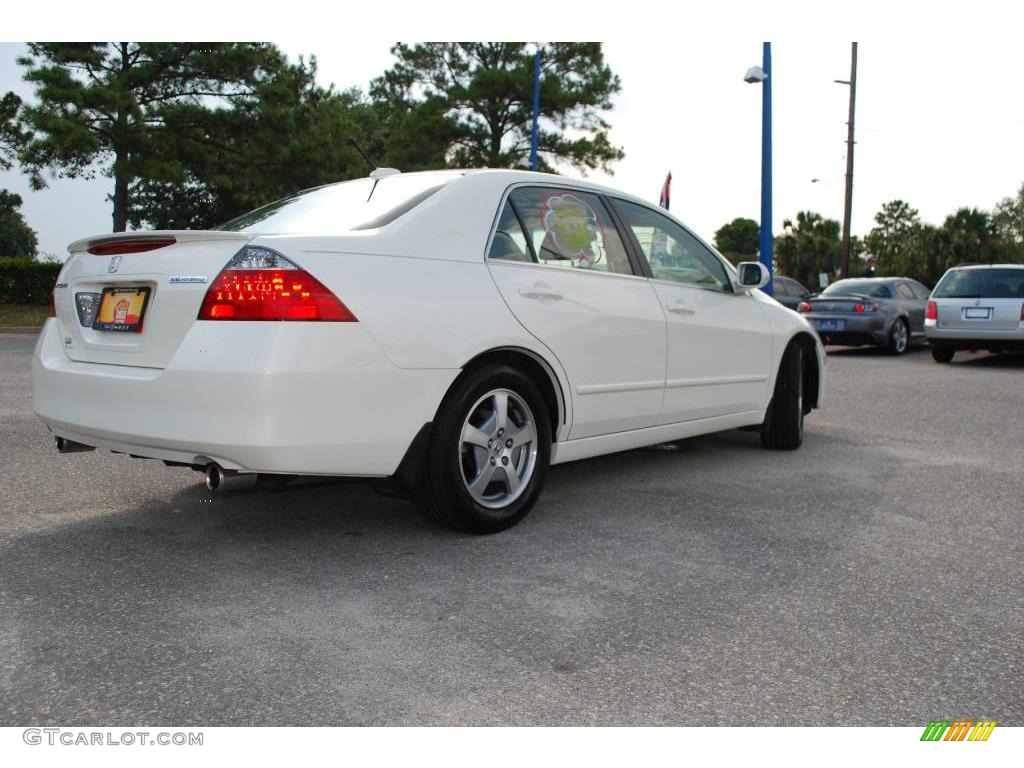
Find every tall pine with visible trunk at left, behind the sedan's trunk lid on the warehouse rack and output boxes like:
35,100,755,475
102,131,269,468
18,43,284,231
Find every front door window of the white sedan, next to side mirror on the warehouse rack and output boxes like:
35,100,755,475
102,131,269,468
615,200,732,293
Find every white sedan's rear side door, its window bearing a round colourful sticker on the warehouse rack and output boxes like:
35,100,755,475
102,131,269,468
487,186,666,439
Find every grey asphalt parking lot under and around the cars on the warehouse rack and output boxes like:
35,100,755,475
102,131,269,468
0,336,1024,726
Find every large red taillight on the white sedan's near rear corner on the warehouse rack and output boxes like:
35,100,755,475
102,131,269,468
199,246,356,323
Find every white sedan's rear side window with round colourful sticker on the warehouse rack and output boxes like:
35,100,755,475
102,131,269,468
487,187,633,274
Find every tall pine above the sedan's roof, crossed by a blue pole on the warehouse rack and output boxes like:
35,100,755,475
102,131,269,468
371,42,624,170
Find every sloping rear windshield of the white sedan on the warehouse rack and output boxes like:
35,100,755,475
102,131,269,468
217,173,461,234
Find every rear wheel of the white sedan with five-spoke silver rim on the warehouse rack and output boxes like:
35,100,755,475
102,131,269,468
415,365,551,534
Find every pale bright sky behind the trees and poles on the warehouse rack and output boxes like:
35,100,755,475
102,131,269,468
0,37,1024,258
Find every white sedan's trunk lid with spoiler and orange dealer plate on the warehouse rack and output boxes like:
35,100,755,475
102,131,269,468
54,231,251,368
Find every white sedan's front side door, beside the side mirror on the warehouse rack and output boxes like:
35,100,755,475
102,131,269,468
613,200,772,424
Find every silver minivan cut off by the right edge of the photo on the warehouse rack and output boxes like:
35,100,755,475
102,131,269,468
925,264,1024,362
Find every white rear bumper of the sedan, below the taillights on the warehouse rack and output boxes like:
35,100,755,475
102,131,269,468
32,321,459,477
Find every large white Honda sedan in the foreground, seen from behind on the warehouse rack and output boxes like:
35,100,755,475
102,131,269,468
33,169,825,532
